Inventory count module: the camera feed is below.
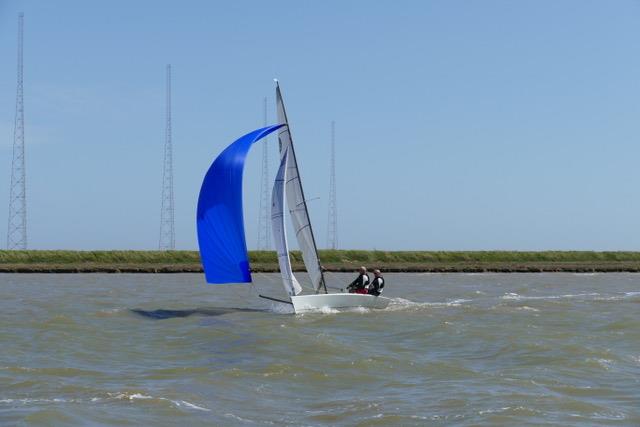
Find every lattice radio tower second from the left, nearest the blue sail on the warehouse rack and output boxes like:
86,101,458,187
159,64,176,251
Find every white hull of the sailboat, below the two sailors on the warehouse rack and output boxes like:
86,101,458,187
291,293,390,313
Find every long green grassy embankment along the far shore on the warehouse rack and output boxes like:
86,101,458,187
0,250,640,273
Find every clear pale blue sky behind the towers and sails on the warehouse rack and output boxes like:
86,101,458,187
0,0,640,250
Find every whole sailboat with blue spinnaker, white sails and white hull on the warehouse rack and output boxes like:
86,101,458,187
197,81,390,313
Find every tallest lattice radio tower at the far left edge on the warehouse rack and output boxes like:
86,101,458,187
7,13,27,250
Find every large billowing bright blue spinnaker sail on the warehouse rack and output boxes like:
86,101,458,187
197,125,284,283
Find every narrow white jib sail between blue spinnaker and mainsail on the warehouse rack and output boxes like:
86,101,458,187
271,150,302,296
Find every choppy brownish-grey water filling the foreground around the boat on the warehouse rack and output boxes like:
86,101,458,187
0,274,640,426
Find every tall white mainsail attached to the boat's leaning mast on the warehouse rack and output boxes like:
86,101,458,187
276,84,327,292
